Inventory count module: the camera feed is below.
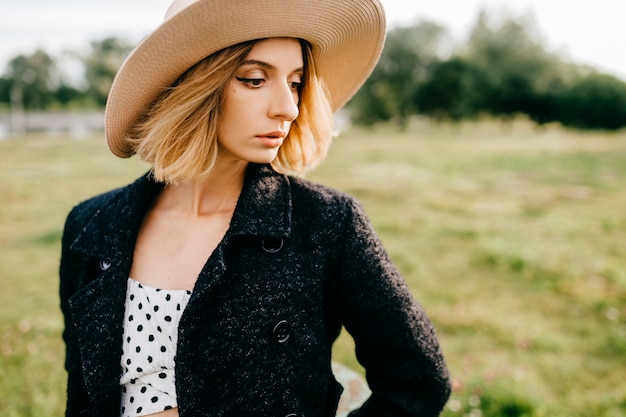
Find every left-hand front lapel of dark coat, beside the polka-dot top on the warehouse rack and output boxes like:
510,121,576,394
70,174,162,415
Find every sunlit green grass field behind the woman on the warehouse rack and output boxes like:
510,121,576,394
0,118,626,417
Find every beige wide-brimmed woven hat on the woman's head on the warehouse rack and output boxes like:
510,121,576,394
105,0,386,157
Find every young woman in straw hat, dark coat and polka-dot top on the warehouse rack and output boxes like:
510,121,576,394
60,0,450,417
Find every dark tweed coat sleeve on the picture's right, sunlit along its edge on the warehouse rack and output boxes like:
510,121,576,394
339,199,451,417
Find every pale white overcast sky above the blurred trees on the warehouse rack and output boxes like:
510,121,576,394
0,0,626,80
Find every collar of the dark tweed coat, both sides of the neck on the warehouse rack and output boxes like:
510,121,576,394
72,164,291,267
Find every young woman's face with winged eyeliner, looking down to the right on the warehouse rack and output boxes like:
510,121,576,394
218,38,304,163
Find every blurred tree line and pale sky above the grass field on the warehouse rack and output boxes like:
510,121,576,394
0,0,626,137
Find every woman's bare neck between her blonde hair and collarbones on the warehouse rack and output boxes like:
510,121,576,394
157,162,248,217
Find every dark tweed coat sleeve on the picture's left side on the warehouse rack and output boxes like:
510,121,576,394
59,203,90,417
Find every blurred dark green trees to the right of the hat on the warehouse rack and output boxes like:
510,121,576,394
349,11,626,129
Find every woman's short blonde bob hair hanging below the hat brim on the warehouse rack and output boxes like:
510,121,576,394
126,40,333,184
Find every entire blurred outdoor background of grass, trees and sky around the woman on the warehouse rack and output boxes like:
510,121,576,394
0,0,626,417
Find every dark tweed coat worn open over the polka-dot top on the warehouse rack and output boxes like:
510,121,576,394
60,165,450,417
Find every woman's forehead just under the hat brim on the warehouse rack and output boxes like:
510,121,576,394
246,38,303,70
